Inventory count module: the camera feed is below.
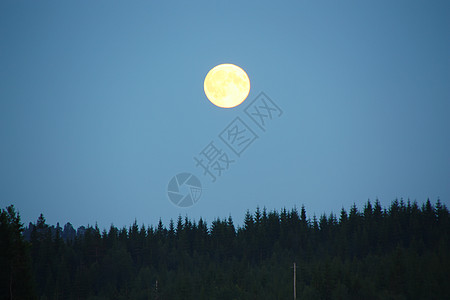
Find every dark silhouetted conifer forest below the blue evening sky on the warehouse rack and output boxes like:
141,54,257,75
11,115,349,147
0,199,450,300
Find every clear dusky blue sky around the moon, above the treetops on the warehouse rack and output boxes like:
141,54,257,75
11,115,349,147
0,0,450,228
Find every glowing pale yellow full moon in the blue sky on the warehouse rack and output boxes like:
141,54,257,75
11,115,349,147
204,64,250,108
